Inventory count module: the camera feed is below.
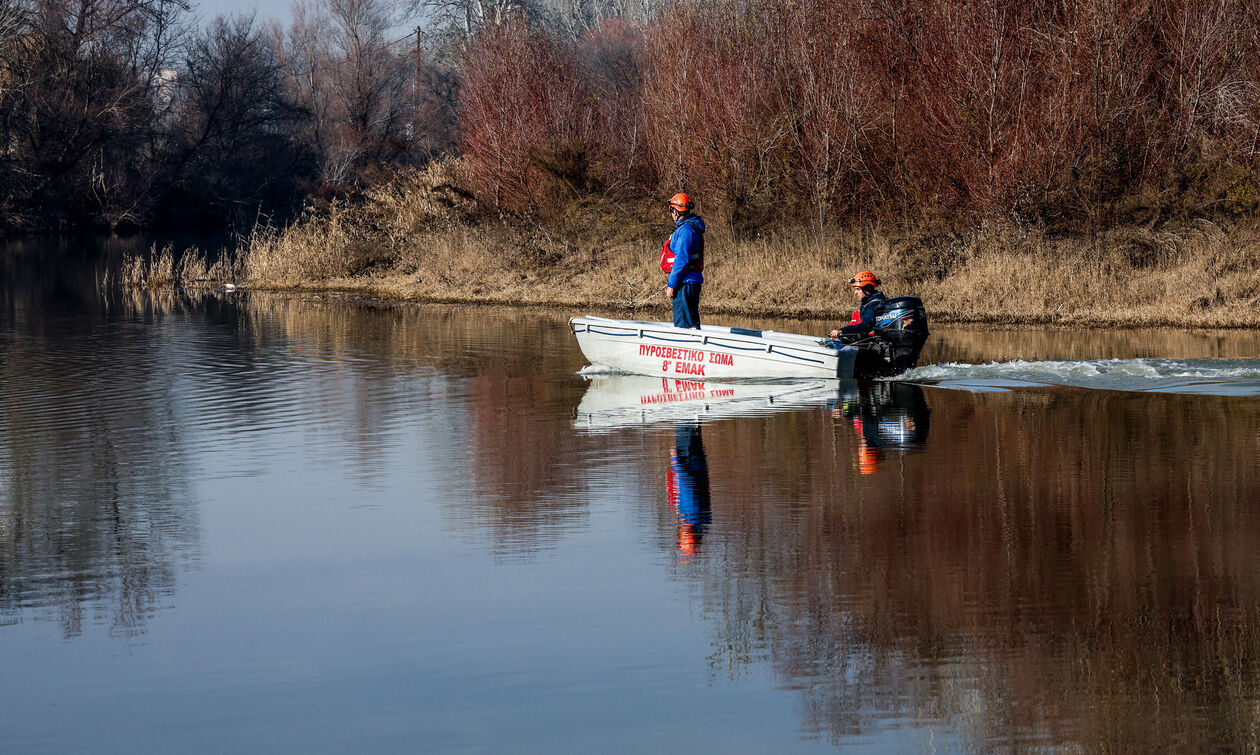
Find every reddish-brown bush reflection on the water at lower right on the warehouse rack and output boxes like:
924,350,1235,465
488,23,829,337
694,386,1260,750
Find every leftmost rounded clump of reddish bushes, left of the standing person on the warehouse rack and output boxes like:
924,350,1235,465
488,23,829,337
459,20,643,212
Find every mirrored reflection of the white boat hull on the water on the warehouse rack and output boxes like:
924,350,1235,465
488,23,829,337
573,374,841,431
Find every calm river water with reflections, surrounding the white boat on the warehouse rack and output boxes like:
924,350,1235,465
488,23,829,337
0,241,1260,752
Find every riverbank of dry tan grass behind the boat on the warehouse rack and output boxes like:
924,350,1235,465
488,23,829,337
123,163,1260,328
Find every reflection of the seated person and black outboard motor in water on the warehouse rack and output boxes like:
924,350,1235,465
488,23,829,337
832,382,931,474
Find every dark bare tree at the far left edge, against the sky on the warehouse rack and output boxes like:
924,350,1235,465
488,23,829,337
5,0,188,226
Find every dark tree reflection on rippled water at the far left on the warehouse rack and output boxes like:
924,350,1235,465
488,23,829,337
0,247,199,637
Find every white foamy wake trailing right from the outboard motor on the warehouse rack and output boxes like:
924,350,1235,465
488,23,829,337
897,359,1260,396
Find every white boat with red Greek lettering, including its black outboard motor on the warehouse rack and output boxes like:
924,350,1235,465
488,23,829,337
570,296,927,381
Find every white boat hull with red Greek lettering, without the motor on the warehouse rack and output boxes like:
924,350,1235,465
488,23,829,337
570,316,868,381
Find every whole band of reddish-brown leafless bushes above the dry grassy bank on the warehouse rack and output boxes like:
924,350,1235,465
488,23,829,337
460,0,1260,232
